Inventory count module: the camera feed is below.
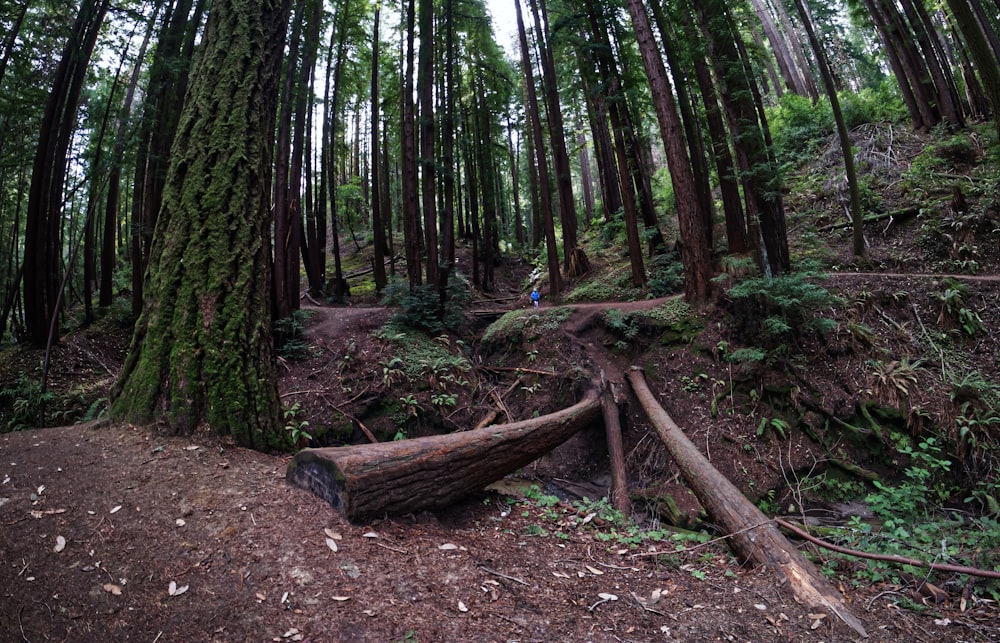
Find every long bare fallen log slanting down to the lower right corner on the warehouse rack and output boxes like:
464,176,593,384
628,366,868,638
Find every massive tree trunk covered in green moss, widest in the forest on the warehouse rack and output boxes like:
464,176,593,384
111,0,289,449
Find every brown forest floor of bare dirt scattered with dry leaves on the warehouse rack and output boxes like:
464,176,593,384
0,123,1000,643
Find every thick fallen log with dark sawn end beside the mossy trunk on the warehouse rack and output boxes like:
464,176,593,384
285,385,601,522
